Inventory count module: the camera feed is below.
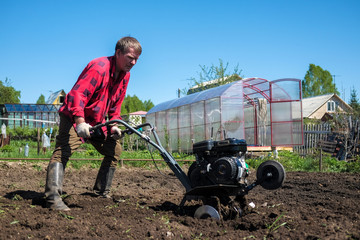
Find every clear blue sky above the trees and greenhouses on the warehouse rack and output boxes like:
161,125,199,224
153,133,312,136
0,0,360,105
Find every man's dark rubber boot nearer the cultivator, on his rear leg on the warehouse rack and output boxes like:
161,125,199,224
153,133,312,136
93,166,116,198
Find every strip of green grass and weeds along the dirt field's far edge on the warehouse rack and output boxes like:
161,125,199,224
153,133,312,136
0,140,360,173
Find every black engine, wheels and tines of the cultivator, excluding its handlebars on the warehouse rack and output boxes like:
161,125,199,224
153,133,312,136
182,138,285,219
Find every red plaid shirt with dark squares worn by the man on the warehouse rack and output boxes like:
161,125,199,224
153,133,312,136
59,56,130,126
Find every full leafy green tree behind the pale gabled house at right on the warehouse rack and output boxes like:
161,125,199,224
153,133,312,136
302,64,339,97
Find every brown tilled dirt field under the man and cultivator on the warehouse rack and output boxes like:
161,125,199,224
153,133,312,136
0,162,360,239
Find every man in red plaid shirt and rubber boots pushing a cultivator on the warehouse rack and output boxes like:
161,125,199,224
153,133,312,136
45,37,142,211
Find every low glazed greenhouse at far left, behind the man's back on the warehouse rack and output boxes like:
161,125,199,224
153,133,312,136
0,103,61,128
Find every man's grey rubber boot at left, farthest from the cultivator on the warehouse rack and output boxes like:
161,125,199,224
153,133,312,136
45,162,70,211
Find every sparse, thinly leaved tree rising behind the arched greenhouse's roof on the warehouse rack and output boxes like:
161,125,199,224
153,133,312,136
181,59,242,95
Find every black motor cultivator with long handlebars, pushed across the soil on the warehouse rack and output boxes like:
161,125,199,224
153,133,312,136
91,120,285,220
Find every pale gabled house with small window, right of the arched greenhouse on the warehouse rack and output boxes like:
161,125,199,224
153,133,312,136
302,93,352,120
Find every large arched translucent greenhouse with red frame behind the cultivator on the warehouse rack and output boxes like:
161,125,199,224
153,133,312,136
146,78,303,152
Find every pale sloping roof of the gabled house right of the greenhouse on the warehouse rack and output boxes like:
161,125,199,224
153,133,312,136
302,93,351,118
